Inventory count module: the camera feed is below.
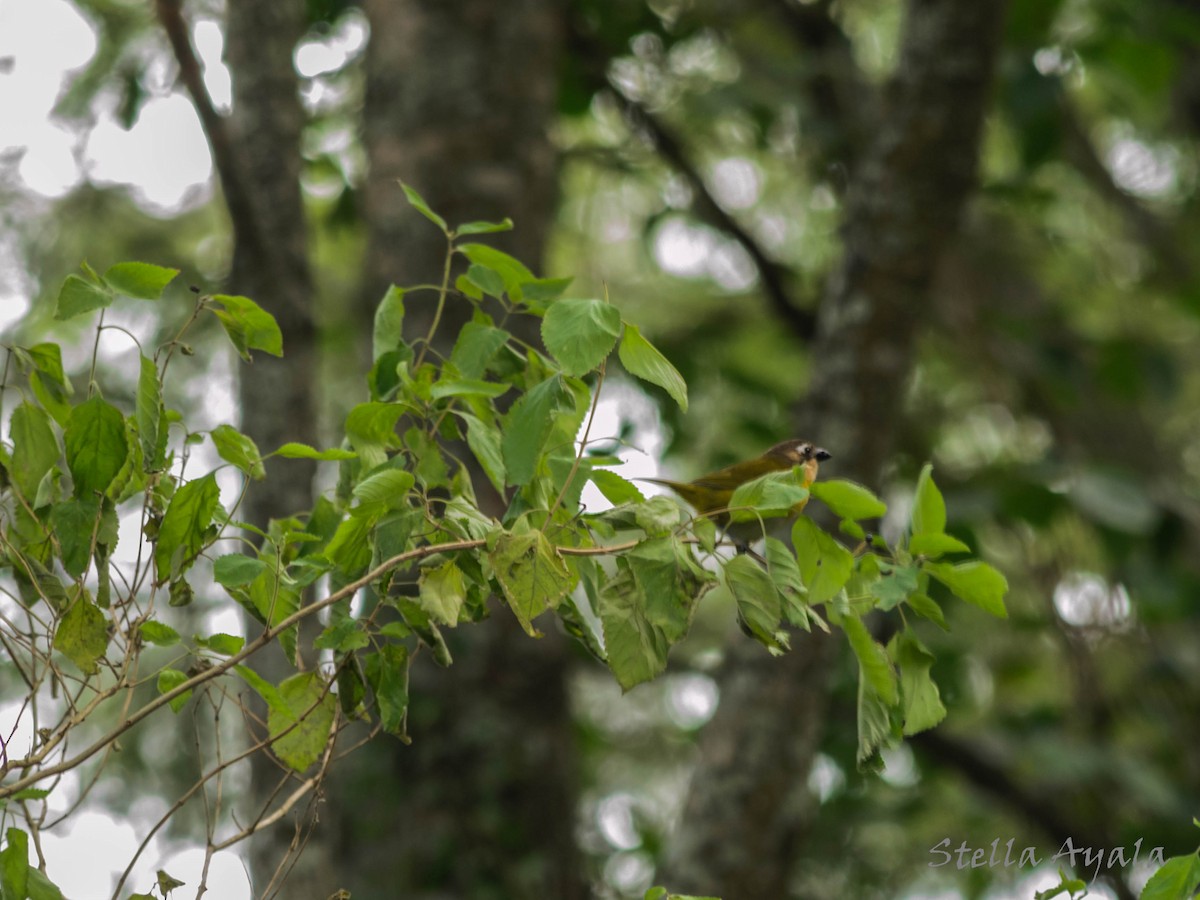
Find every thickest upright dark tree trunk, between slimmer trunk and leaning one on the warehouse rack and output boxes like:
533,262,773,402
309,0,586,900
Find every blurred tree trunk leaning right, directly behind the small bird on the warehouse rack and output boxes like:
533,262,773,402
659,0,1003,900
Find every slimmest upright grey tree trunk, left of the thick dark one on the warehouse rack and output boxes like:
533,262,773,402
221,0,330,896
